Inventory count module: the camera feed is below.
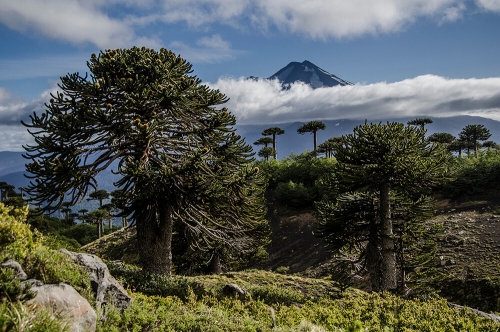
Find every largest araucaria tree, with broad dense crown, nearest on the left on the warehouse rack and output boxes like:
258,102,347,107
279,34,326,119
25,47,266,274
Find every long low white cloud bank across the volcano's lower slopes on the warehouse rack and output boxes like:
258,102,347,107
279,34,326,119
209,75,500,124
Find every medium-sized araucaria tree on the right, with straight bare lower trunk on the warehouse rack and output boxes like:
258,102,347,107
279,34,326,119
316,123,451,291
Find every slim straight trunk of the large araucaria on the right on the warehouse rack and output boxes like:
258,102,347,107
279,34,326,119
380,183,397,292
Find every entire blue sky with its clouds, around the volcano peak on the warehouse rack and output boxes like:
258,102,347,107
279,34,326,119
0,0,500,151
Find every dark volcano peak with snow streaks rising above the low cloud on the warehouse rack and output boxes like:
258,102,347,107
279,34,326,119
269,60,352,89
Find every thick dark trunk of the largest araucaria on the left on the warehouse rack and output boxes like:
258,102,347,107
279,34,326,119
137,202,173,275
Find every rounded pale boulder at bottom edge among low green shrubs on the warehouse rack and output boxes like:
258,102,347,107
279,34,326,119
22,279,97,332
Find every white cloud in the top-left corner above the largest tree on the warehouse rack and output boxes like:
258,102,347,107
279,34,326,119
0,0,157,48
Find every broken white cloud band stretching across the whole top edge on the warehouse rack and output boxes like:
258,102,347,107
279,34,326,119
0,0,500,50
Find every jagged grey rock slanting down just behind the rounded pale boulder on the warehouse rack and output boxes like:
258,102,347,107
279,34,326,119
60,249,132,309
